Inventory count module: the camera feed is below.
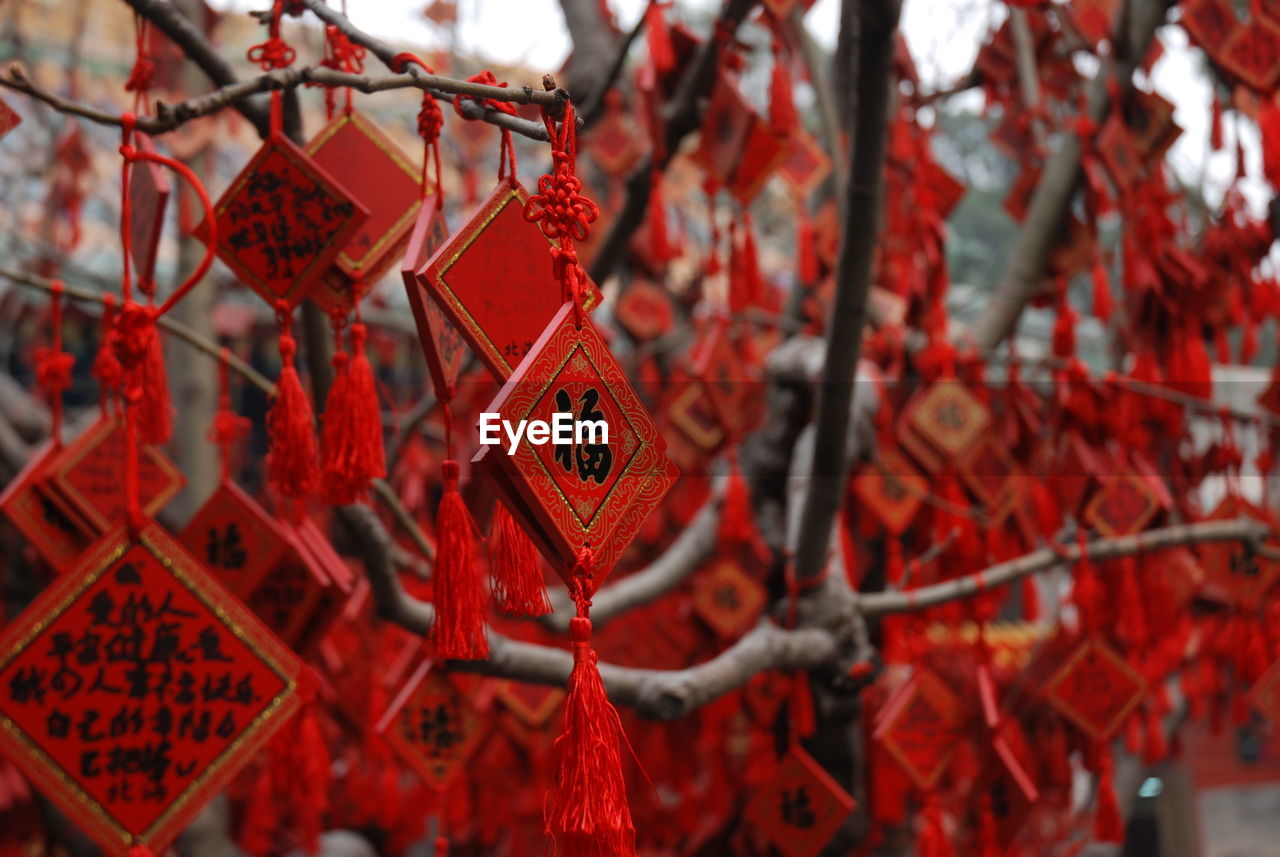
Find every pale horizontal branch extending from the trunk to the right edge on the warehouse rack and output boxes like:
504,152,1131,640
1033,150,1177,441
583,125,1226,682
858,518,1271,617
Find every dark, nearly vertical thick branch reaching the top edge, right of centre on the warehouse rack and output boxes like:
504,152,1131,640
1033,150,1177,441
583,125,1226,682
795,0,899,581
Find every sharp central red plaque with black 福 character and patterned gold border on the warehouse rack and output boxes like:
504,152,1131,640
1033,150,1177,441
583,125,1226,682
474,303,676,591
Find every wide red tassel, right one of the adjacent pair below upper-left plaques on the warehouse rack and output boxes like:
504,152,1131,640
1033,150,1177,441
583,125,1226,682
323,322,387,505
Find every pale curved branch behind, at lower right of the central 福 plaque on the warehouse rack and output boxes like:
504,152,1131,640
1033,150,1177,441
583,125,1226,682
545,478,726,633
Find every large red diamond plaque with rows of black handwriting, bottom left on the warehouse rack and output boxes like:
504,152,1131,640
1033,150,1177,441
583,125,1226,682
0,522,303,857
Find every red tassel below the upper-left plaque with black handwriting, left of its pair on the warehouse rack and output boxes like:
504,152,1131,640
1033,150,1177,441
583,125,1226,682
266,331,319,500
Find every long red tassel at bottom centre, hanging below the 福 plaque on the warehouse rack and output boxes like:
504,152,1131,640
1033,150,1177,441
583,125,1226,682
547,619,634,857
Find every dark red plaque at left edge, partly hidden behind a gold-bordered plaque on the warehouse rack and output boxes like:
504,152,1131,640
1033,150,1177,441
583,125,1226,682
0,444,96,572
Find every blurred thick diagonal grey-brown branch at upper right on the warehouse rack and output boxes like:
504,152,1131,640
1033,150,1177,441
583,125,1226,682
975,0,1167,349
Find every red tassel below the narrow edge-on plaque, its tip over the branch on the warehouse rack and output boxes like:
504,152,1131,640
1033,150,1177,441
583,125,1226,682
431,460,489,660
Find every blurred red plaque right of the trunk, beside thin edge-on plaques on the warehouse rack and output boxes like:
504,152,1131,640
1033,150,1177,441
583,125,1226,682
874,669,964,792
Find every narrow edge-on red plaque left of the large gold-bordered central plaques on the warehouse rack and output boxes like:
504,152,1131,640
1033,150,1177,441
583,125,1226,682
401,200,467,398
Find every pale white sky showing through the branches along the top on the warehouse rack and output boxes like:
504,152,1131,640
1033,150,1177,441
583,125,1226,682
214,0,1268,215
